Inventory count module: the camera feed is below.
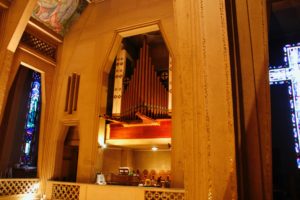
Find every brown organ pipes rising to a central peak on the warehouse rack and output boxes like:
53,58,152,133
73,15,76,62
121,40,168,120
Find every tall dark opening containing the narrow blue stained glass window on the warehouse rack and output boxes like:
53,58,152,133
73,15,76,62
0,65,42,178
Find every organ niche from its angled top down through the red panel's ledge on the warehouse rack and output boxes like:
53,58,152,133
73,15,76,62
101,31,172,148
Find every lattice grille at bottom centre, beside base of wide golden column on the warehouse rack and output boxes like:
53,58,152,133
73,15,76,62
145,190,184,200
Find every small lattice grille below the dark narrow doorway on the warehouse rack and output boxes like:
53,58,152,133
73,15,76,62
52,184,80,200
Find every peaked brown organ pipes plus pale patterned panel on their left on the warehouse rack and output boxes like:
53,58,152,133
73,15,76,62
113,39,170,121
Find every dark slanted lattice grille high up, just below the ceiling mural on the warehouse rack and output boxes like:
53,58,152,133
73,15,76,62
21,32,57,61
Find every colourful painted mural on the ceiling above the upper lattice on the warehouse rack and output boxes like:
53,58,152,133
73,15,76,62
32,0,88,36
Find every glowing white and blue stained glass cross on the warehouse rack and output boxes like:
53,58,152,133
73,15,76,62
269,43,300,169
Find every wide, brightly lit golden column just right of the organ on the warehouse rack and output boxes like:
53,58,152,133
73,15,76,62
173,0,237,200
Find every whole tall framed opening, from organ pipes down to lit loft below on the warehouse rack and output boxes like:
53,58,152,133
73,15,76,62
98,22,172,186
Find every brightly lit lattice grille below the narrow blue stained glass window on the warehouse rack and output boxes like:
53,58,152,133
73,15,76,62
0,179,39,197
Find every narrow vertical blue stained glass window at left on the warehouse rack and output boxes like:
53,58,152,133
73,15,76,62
20,72,41,166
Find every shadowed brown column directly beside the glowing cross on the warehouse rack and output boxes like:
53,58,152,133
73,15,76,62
233,0,272,199
